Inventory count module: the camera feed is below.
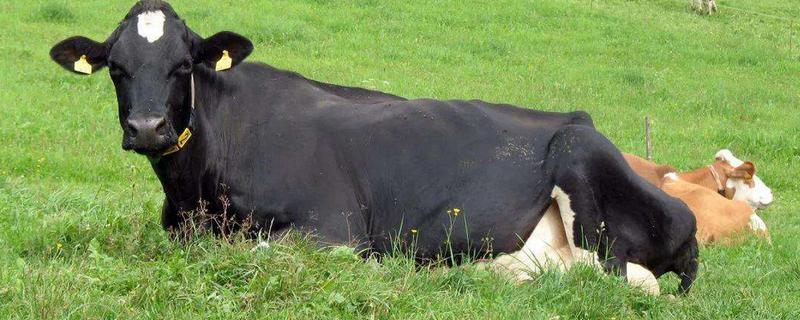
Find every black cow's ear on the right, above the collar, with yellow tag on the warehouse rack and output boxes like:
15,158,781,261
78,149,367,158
194,31,253,71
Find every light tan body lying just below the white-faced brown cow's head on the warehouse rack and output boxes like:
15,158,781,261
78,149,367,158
661,173,768,243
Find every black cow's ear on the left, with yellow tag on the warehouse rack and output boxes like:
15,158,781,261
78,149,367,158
50,37,108,75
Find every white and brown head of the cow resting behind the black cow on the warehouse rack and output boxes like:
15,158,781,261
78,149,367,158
715,149,773,208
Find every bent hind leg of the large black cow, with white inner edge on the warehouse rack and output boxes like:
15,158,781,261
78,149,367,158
546,126,696,292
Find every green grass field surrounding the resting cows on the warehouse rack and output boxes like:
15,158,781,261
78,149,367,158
0,0,800,319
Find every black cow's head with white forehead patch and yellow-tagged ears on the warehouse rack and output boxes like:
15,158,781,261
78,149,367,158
50,0,253,156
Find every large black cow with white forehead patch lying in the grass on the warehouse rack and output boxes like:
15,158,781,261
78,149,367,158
51,0,697,291
